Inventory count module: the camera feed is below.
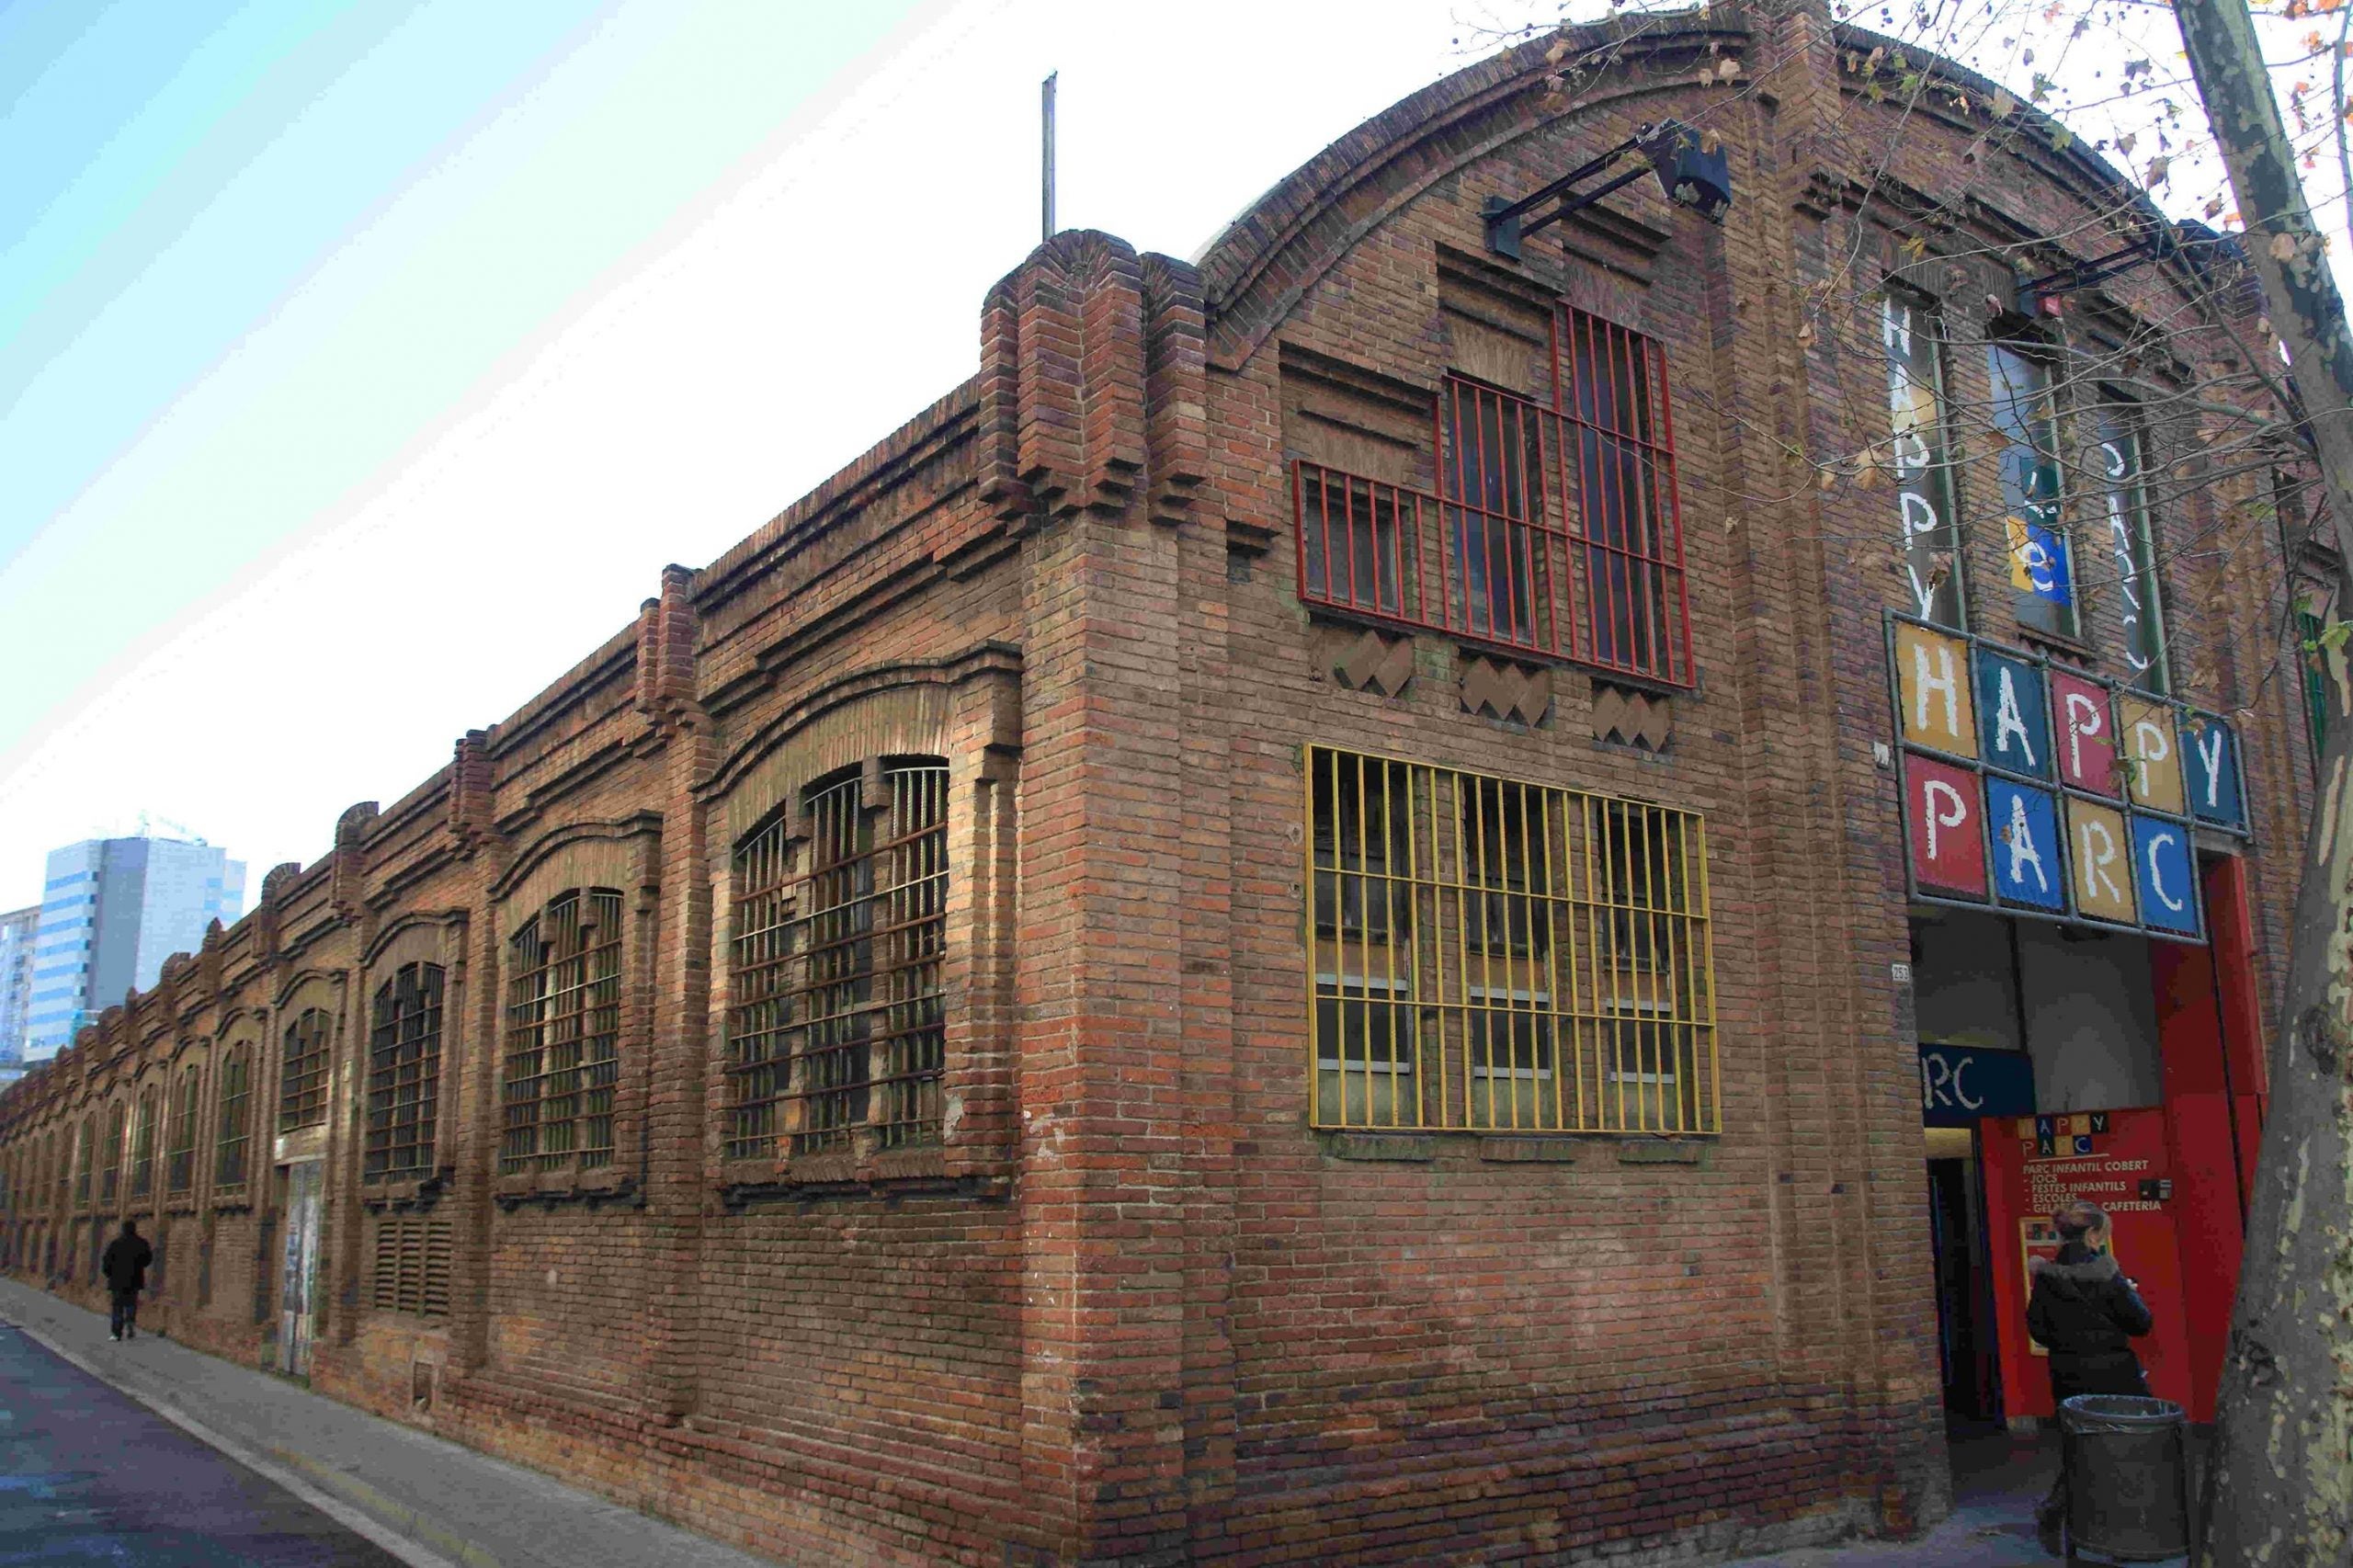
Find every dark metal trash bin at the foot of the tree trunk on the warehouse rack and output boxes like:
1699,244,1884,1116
2059,1393,2190,1563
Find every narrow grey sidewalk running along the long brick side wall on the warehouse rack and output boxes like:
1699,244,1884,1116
0,1278,777,1568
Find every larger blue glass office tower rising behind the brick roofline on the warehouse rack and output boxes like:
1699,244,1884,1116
24,838,244,1060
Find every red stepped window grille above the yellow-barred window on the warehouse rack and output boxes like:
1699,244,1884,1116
1291,309,1692,685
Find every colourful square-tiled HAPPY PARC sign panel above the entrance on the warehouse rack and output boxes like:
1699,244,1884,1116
1887,615,2247,942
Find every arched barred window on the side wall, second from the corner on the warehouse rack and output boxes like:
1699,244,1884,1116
499,888,621,1173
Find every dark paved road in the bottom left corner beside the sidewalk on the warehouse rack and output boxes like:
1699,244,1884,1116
0,1324,398,1568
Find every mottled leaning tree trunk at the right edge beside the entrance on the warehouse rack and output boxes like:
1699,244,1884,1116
2177,0,2353,1568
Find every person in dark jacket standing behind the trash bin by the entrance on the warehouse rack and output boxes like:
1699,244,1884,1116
2026,1199,2155,1554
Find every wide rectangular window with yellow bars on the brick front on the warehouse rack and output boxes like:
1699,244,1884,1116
1308,746,1718,1132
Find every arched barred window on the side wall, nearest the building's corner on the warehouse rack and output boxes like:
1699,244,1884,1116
727,758,949,1158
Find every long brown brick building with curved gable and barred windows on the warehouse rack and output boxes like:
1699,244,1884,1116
0,12,2311,1563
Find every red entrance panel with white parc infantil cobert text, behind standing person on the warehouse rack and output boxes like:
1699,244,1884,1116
1979,1107,2214,1422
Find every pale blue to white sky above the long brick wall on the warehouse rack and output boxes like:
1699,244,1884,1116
0,0,1489,909
